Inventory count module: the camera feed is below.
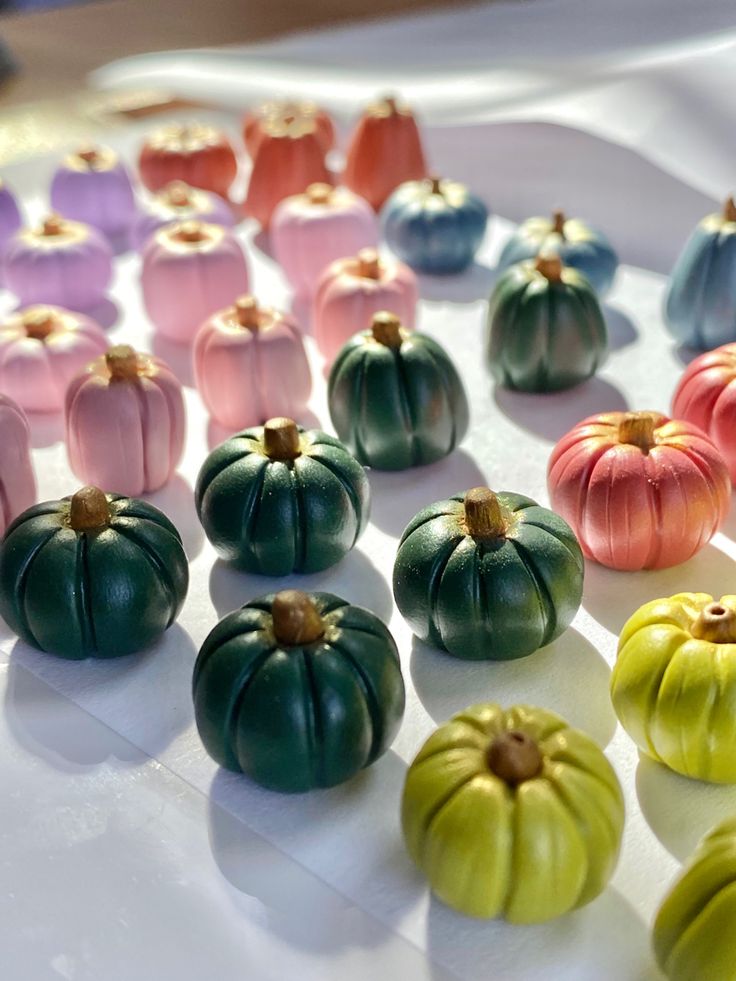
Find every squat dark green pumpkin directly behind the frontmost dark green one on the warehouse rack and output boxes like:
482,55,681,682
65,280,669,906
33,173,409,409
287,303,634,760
195,419,370,576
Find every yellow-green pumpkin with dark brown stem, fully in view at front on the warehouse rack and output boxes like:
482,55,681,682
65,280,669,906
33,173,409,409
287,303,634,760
401,704,624,923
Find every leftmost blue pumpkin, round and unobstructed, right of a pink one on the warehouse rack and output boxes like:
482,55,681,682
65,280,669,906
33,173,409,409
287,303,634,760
381,177,488,274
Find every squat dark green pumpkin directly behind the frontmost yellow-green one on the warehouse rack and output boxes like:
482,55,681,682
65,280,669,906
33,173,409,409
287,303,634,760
393,487,583,661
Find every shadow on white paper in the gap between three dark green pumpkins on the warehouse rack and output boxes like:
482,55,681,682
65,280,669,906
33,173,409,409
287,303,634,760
368,449,489,538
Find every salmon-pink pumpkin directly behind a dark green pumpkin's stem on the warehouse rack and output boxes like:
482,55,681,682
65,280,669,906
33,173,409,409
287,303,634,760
312,249,419,364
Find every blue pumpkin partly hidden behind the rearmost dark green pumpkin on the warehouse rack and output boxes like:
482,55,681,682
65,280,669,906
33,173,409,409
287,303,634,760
498,211,618,296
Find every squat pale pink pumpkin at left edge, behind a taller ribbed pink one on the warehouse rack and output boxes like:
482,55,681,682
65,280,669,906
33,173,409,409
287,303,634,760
0,306,108,412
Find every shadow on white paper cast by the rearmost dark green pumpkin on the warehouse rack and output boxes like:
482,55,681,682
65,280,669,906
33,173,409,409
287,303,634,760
493,376,628,443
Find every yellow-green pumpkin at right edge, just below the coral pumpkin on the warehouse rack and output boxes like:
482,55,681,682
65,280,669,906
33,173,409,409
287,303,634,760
611,593,736,783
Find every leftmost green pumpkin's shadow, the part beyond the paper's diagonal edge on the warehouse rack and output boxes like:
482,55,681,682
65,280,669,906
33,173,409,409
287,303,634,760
4,657,148,773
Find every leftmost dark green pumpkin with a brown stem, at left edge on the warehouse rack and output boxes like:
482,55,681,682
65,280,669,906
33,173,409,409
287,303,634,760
0,487,189,660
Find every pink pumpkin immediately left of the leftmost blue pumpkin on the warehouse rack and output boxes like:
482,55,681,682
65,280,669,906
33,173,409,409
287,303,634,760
271,184,378,296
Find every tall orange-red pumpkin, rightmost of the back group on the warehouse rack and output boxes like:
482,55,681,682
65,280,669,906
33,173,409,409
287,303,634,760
343,97,427,211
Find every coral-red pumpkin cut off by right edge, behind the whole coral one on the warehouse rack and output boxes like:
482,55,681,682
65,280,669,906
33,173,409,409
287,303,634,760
672,344,736,485
